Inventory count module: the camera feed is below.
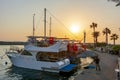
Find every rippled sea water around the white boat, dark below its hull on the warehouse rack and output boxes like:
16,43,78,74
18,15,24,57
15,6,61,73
0,45,68,80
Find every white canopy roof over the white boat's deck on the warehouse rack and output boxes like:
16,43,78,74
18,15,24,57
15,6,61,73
25,41,68,52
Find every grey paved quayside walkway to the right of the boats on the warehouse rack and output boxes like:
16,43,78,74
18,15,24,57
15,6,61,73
74,52,117,80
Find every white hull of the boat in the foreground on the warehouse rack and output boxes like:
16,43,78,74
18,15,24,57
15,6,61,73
8,54,70,73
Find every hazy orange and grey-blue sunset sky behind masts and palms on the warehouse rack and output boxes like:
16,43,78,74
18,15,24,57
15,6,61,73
0,0,120,44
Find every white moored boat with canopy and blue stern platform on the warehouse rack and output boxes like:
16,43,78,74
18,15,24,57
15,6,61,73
6,9,76,73
